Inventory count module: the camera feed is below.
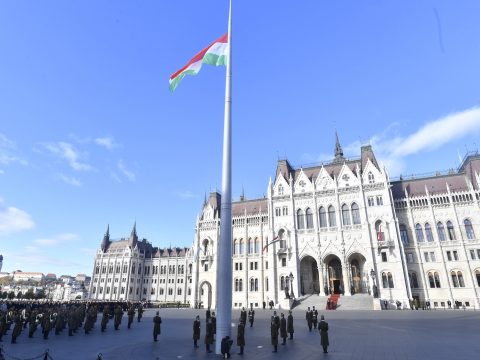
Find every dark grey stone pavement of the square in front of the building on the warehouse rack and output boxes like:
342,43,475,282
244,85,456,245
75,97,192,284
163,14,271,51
0,309,480,360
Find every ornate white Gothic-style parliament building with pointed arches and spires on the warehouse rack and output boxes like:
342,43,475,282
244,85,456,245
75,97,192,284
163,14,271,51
90,138,480,308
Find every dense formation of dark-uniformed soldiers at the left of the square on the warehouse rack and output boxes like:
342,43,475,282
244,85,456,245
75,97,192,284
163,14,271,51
0,302,143,344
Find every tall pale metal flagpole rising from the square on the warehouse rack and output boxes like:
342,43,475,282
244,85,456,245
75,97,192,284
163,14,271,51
215,0,232,354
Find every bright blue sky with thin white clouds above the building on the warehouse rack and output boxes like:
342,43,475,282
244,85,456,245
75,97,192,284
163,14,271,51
0,0,480,275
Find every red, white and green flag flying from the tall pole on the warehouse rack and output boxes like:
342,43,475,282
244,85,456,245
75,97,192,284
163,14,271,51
170,34,228,91
